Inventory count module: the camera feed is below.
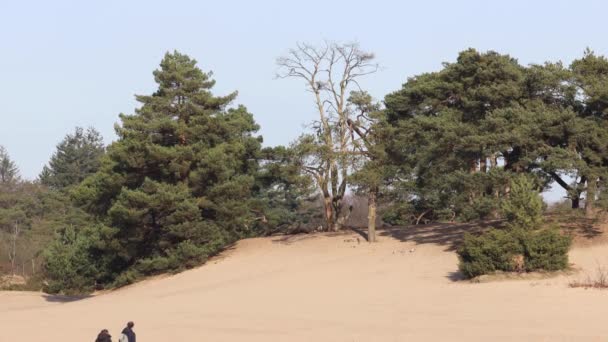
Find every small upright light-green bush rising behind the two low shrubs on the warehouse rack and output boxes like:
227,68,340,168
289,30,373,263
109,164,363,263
502,175,543,229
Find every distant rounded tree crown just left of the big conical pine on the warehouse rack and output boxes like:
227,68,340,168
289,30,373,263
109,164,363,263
38,127,105,189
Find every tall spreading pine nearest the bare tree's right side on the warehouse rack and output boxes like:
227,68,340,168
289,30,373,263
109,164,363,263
385,49,527,223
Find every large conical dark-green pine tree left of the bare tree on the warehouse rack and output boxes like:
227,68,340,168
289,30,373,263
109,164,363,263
74,52,266,282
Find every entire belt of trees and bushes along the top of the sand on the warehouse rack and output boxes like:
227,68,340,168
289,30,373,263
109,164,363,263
0,42,608,294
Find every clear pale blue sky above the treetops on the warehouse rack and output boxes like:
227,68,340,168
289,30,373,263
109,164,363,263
0,0,608,200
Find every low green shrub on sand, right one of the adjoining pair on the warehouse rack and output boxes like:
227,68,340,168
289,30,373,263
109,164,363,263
523,229,572,271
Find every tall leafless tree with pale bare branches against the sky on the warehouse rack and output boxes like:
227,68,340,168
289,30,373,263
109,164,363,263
277,42,378,231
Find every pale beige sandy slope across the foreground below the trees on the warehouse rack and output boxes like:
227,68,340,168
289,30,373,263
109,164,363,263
0,224,608,342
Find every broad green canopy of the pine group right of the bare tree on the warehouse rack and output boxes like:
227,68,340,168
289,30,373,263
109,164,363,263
382,49,608,224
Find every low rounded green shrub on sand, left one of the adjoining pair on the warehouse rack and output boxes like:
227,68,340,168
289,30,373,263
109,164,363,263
458,229,524,278
